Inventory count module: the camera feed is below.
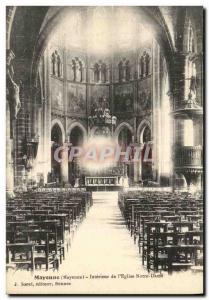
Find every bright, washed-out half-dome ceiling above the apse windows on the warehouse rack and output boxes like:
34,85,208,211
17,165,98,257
51,7,154,55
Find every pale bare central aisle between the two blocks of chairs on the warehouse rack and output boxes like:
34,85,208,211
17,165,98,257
60,192,144,274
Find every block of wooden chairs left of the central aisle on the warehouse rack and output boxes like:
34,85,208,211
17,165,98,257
6,191,92,271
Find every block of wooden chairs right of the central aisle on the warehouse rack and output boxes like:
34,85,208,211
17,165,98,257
119,192,203,273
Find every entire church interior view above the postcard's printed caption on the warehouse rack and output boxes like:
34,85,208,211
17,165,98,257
6,6,204,284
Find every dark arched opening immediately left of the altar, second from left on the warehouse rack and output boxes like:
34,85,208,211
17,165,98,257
68,125,84,186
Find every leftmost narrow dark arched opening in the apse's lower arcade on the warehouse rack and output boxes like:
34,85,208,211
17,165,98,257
48,124,63,183
